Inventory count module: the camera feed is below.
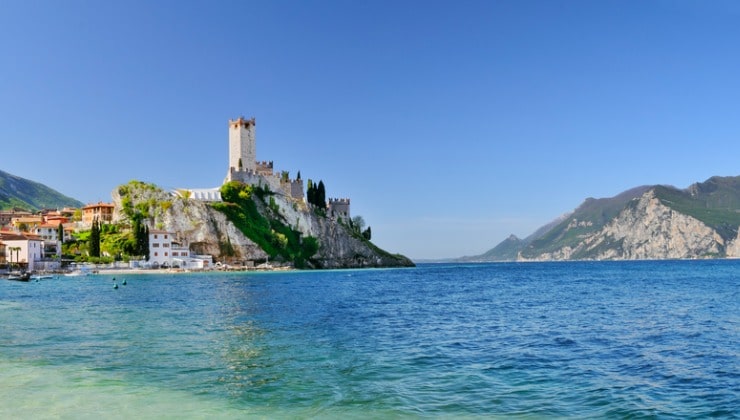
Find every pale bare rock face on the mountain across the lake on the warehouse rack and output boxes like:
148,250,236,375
534,190,729,260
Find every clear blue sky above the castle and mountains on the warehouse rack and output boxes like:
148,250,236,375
0,0,740,258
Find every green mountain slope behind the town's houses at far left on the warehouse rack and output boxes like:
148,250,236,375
0,171,83,211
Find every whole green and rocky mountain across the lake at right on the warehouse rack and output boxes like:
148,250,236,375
464,176,740,261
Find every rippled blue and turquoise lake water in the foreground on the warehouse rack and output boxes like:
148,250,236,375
0,261,740,419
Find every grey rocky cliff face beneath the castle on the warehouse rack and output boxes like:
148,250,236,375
112,181,413,268
